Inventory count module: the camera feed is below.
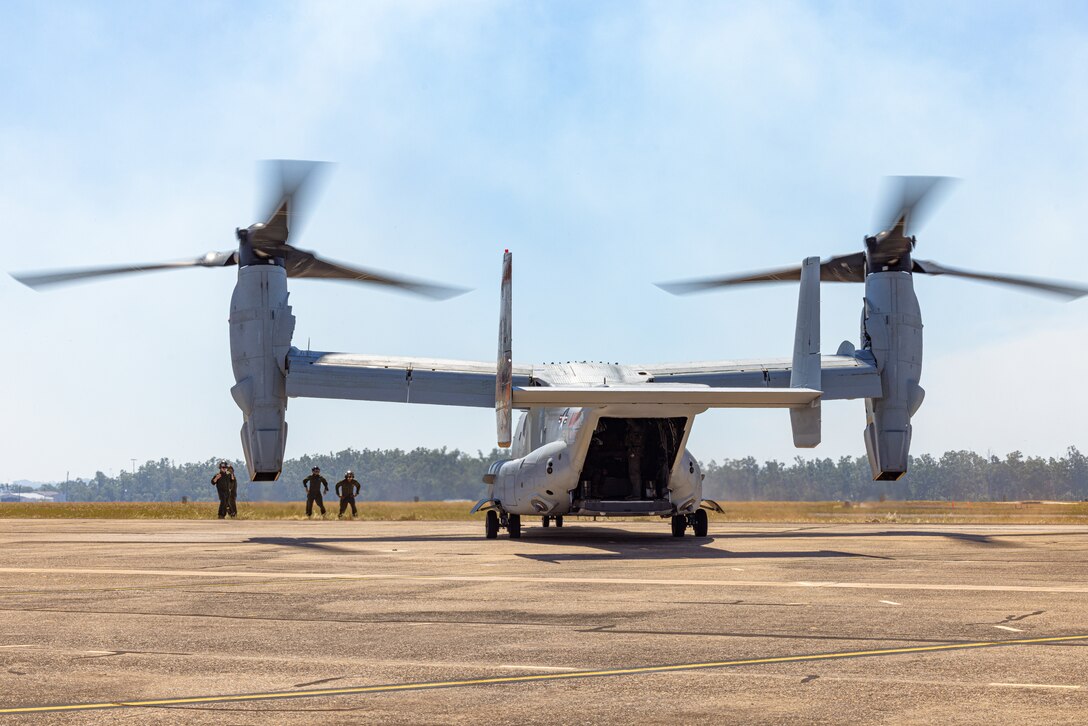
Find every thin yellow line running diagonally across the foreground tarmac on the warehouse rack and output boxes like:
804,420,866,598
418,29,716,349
0,635,1088,714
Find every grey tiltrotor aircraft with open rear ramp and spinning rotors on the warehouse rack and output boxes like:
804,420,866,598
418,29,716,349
15,162,1088,538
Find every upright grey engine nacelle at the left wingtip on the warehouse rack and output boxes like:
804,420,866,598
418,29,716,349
231,264,295,481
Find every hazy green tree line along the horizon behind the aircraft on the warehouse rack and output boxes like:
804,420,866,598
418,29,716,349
21,446,1088,502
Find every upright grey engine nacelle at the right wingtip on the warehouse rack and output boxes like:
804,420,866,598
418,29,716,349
862,272,926,480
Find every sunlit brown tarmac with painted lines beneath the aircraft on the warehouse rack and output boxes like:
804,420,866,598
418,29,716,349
0,519,1088,726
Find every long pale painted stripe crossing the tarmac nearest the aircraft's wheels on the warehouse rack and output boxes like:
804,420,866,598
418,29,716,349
0,567,1088,594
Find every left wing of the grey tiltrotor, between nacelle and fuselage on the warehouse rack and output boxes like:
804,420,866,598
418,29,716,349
287,348,533,408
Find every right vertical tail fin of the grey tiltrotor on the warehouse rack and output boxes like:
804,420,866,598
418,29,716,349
790,257,821,448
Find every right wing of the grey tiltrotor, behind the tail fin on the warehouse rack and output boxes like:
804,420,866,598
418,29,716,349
632,352,883,401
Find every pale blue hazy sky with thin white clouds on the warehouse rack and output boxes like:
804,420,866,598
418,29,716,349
0,0,1088,481
